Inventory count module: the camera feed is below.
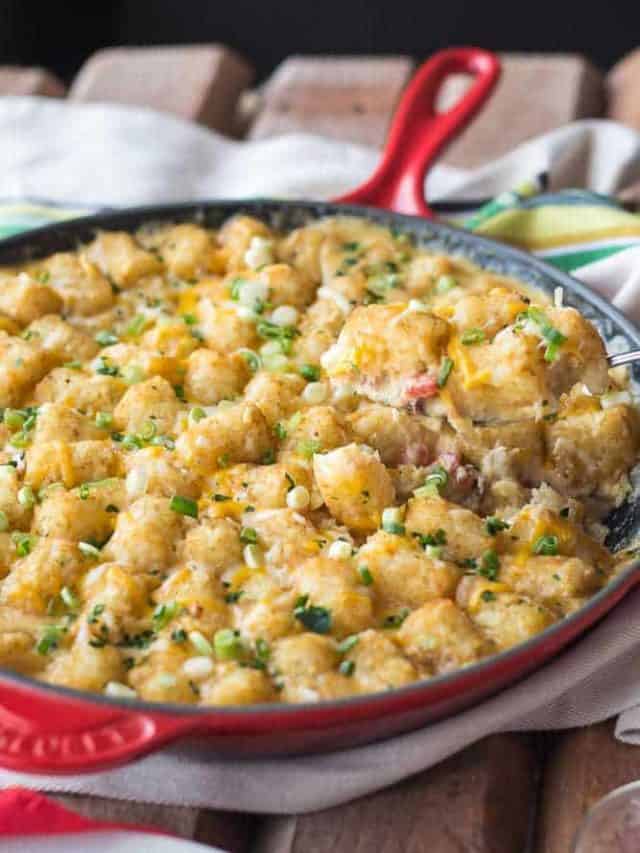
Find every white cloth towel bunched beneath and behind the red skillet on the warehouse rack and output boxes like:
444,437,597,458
0,93,640,813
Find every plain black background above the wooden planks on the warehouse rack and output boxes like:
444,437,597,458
0,0,640,81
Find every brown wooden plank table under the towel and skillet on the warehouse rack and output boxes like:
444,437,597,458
0,45,640,853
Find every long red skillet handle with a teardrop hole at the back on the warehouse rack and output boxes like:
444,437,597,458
335,47,500,218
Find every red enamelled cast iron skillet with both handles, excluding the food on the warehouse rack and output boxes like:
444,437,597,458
0,48,640,773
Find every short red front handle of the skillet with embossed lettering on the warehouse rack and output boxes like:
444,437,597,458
0,683,198,774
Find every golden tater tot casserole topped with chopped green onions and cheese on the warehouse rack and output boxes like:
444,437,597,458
0,215,640,706
